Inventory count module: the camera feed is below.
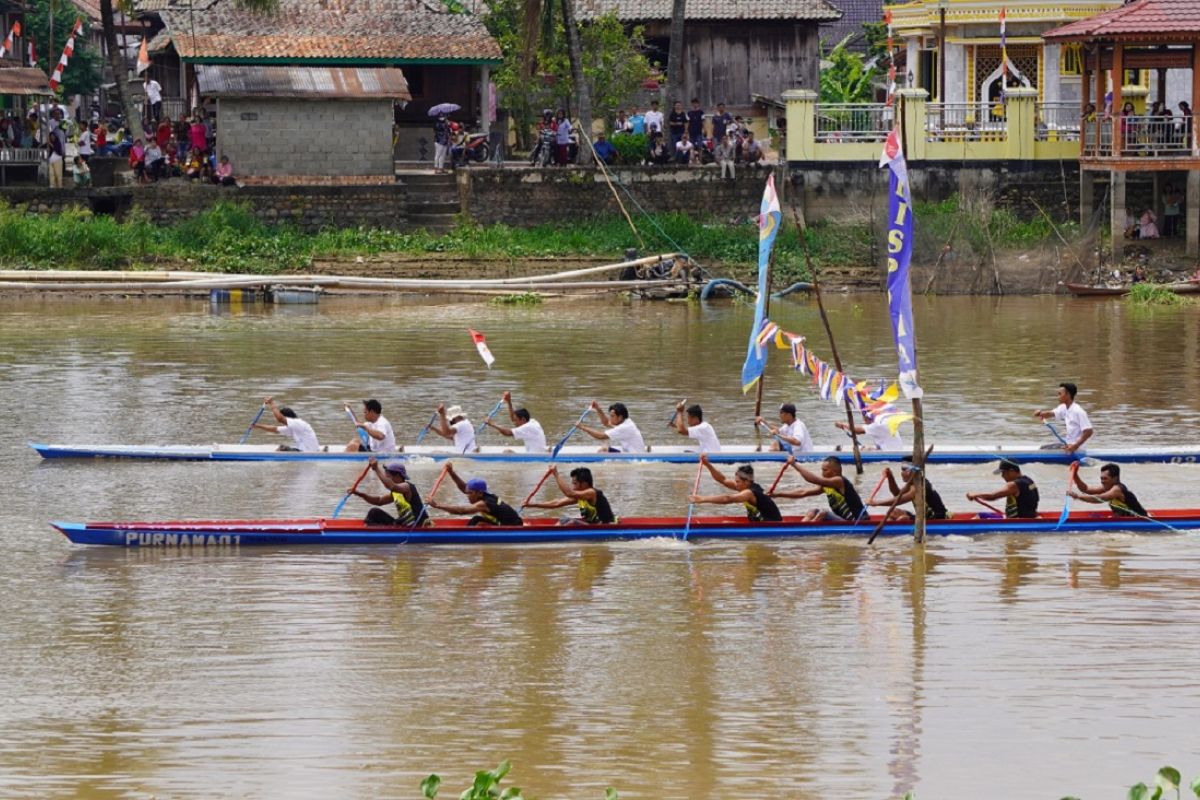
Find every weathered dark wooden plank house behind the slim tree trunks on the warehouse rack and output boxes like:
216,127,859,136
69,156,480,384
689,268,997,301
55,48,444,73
575,0,841,109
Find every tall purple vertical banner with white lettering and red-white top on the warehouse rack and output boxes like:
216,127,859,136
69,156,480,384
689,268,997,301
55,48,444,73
880,130,922,399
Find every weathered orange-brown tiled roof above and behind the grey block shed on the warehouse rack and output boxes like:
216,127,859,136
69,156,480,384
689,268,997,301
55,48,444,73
161,0,500,64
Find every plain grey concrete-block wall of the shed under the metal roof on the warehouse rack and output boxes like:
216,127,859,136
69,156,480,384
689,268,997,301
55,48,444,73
217,97,394,176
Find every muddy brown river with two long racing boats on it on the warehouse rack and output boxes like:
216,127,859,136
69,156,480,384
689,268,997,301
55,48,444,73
0,295,1200,800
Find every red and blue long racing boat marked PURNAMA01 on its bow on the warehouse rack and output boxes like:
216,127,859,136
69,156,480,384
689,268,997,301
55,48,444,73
50,509,1200,548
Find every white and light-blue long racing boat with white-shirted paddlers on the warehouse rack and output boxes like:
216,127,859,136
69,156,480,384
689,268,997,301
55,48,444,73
29,439,1200,464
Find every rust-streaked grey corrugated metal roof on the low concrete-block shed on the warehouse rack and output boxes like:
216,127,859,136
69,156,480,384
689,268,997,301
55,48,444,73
196,64,413,101
